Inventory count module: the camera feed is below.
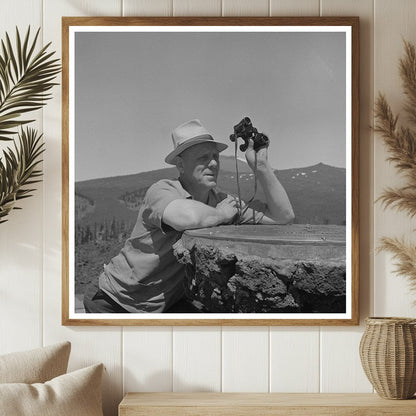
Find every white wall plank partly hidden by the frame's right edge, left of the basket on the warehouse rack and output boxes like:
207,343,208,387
321,0,374,392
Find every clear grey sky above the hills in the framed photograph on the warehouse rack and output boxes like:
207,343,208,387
73,32,346,181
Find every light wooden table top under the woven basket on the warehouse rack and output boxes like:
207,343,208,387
119,393,416,416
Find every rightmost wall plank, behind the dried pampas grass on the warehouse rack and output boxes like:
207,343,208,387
374,0,416,316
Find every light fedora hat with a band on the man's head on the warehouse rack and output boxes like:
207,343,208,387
165,119,228,165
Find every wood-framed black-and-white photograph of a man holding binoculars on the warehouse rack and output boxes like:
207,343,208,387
62,17,359,326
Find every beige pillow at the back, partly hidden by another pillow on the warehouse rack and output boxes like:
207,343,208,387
0,342,71,384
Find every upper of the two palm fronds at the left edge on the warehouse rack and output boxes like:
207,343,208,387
0,27,61,140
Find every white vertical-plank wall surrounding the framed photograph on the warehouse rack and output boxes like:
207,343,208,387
0,0,416,416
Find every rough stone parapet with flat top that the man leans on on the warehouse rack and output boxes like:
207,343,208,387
174,224,346,313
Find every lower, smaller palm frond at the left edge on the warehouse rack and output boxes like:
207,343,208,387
0,128,44,224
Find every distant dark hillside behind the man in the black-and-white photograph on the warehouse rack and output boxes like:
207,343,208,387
75,156,346,232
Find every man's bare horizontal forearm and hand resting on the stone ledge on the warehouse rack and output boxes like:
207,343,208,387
162,197,237,231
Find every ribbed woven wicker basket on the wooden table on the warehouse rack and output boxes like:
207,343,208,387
360,317,416,399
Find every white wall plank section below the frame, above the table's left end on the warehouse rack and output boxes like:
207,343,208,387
123,327,172,393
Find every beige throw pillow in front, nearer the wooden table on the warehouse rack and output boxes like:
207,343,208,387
0,364,103,416
